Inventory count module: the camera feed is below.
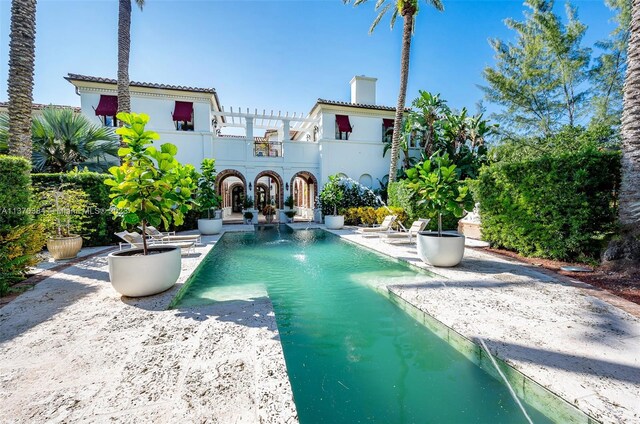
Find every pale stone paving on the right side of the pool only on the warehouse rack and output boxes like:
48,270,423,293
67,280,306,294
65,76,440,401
300,224,640,423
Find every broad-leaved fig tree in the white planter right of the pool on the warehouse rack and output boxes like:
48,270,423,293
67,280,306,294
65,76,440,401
407,153,473,237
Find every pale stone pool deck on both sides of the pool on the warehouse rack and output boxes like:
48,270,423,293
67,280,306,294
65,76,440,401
0,223,640,423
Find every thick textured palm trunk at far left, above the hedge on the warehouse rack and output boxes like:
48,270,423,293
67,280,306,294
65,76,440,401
7,0,36,160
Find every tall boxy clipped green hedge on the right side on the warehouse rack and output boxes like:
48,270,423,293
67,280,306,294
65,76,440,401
474,149,620,260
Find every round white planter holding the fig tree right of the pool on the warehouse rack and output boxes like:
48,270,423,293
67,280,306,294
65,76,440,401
417,231,464,267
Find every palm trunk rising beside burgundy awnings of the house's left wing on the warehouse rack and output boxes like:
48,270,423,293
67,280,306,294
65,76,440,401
118,0,144,113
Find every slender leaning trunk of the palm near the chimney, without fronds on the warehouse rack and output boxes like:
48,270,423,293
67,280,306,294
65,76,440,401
389,7,416,183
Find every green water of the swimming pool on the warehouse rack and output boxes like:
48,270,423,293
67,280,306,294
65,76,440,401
175,227,551,424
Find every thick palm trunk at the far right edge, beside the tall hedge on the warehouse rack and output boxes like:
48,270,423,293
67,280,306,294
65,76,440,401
603,0,640,267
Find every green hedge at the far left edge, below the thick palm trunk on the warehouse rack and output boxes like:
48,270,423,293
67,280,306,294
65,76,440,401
0,156,45,295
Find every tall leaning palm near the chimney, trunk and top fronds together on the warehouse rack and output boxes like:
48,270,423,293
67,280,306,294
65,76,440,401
343,0,444,183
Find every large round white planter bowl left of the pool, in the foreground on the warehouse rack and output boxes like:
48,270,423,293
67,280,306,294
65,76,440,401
108,246,181,297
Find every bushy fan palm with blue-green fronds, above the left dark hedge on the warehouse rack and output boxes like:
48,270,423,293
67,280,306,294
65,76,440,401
0,107,119,172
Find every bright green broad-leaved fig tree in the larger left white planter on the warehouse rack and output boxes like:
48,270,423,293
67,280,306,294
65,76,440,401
105,112,196,255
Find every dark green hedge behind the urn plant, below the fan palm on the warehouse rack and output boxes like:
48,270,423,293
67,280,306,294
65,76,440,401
31,172,122,246
